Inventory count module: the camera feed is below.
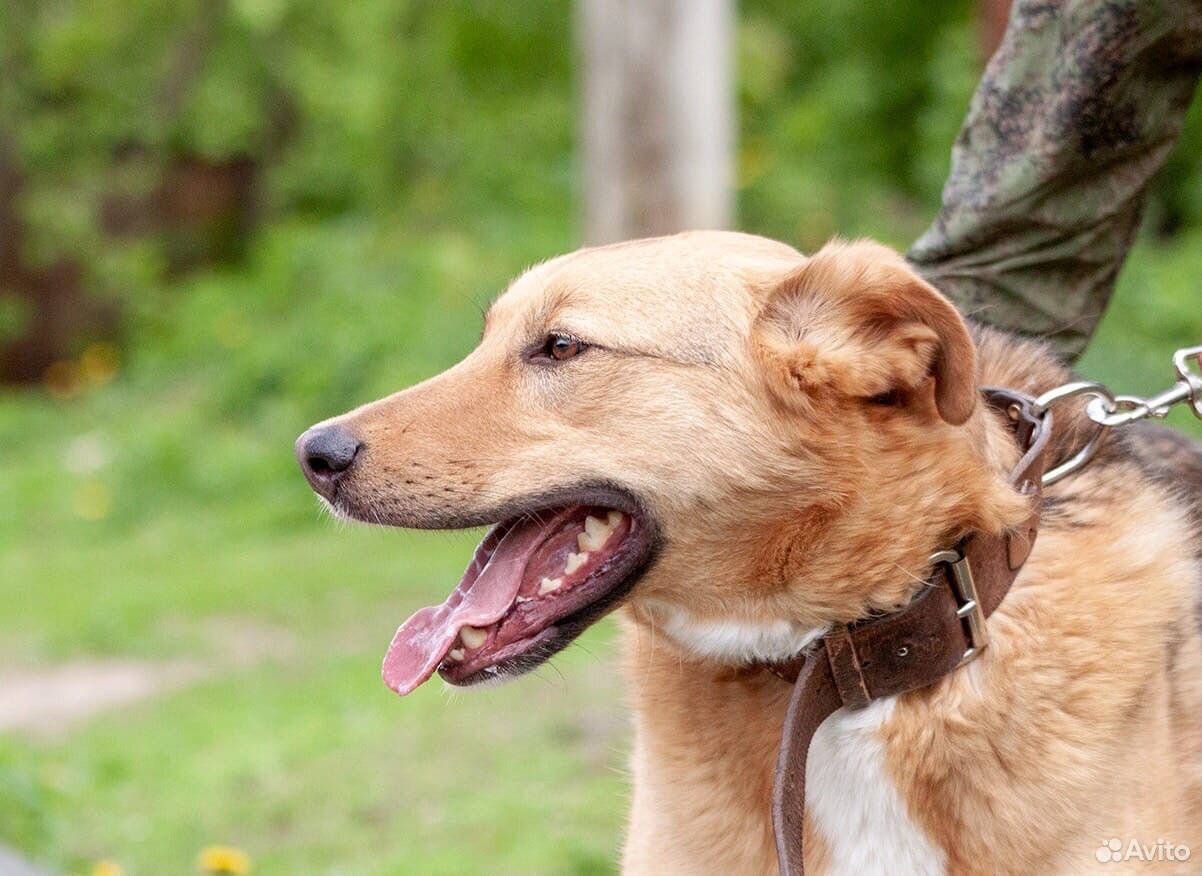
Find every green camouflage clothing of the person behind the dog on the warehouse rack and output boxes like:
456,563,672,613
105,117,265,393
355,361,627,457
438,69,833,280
909,0,1202,359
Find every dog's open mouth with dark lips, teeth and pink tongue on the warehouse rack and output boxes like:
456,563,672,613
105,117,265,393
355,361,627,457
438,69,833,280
383,505,651,695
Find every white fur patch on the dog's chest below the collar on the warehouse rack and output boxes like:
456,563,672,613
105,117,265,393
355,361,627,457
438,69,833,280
805,698,947,876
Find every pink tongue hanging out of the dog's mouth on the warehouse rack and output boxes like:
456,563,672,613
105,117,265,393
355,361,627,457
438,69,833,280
383,513,564,696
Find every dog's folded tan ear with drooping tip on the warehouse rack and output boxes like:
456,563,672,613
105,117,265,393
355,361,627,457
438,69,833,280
754,240,977,425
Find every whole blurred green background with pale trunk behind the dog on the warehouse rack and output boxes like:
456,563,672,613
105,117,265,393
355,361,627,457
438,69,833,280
0,0,1202,876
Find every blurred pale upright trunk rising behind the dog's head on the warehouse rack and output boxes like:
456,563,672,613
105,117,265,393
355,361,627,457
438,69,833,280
578,0,734,244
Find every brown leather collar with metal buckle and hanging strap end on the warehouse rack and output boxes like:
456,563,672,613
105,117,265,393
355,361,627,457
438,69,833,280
764,388,1052,876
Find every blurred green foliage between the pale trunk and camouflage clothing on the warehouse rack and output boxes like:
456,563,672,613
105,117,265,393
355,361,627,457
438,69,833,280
740,0,980,249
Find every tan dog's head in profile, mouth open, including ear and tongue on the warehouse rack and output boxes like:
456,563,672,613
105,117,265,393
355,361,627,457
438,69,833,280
297,233,1025,693
